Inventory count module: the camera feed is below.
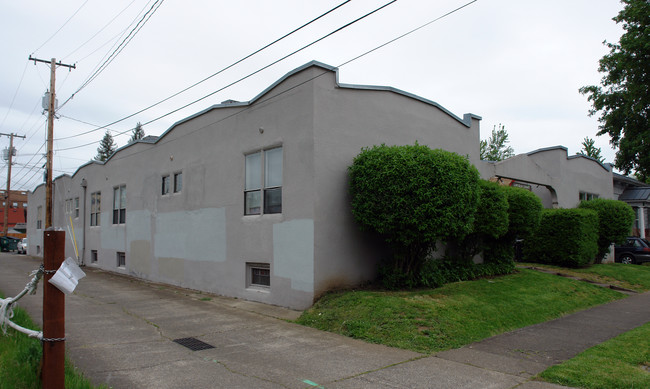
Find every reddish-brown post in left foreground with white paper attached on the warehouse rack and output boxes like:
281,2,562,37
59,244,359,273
41,229,65,389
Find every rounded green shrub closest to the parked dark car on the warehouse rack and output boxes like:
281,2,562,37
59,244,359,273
578,199,635,263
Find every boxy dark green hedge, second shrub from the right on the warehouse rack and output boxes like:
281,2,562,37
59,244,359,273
524,209,598,267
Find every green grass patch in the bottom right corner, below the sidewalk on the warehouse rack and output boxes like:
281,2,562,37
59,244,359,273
540,323,650,389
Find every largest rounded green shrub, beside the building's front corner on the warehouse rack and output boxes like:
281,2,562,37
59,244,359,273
348,143,479,280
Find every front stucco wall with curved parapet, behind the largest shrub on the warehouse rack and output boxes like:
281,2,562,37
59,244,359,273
314,69,479,295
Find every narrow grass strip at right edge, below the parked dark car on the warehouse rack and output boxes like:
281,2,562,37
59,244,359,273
519,263,650,292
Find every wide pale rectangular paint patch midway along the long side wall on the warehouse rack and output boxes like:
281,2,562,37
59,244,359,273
154,208,226,262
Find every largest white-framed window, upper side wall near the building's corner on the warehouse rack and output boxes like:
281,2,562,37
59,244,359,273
244,147,282,215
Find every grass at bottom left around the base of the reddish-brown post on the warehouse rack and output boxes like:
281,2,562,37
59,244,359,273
0,294,101,389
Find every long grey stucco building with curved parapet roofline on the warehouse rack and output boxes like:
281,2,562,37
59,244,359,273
27,62,612,309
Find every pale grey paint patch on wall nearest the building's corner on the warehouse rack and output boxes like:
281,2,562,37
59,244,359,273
273,220,314,292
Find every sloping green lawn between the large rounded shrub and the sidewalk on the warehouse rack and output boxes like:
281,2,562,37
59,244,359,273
297,269,625,353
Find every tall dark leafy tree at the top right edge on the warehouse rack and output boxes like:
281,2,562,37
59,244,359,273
580,0,650,181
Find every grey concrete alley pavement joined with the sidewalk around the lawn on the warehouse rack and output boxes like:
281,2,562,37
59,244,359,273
0,253,650,389
